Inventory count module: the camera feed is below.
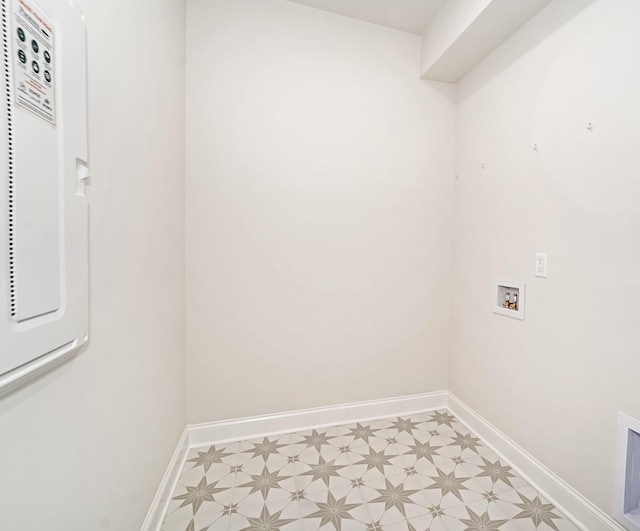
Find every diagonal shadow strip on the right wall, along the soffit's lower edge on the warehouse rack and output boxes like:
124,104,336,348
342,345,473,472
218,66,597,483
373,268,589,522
458,0,596,103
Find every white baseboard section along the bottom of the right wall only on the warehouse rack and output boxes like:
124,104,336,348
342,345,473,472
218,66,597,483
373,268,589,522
447,393,625,531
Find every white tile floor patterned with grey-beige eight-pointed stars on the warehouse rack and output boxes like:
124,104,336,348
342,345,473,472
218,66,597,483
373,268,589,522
162,411,578,531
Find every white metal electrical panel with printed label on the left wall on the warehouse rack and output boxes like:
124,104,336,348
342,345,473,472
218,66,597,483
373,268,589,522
0,0,88,394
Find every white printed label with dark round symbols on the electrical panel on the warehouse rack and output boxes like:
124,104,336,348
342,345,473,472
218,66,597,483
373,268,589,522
13,0,56,125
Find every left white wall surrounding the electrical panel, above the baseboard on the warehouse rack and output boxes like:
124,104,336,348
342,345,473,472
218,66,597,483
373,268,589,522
0,0,185,531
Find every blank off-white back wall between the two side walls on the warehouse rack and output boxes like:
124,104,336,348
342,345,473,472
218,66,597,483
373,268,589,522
186,0,454,422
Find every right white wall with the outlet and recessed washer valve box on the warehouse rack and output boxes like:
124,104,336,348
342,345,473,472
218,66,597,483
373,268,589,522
450,0,640,512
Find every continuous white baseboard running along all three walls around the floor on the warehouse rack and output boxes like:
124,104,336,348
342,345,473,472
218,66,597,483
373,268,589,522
141,391,625,531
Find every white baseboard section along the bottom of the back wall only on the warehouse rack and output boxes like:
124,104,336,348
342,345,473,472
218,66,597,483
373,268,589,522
187,391,447,448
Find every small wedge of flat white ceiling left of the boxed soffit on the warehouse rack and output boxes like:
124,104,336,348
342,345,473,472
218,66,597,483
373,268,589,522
289,0,445,35
